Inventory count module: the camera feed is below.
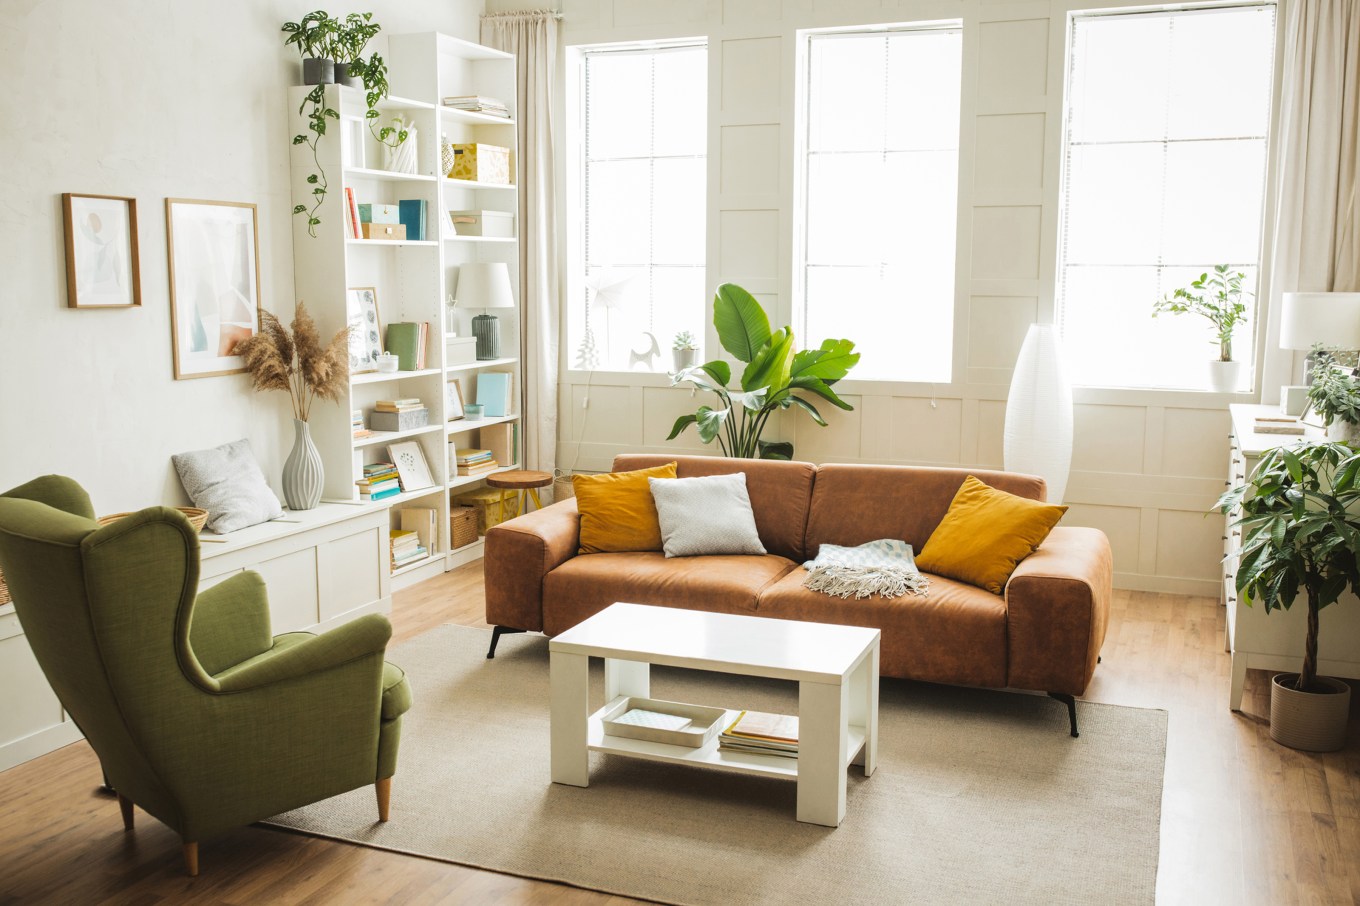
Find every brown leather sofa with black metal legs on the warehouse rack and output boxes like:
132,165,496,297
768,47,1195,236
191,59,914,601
486,454,1112,736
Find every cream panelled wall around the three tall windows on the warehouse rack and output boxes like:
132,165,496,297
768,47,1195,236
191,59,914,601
487,0,1259,594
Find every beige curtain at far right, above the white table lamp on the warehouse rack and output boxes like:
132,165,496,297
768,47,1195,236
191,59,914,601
1263,0,1360,399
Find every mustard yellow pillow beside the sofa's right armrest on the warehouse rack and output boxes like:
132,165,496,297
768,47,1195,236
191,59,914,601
917,475,1068,594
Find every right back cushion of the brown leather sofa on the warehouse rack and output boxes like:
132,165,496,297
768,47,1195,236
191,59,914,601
799,465,1044,555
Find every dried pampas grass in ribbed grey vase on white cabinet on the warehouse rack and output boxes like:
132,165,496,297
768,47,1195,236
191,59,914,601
237,302,350,510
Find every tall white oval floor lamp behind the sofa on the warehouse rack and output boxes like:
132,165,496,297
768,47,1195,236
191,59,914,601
1002,324,1072,503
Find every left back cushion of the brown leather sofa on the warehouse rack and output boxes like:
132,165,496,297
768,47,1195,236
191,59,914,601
613,453,816,562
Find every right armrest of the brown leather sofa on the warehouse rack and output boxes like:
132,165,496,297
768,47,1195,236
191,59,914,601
1005,528,1114,695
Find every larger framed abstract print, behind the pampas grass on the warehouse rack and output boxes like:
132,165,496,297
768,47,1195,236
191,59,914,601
166,199,260,381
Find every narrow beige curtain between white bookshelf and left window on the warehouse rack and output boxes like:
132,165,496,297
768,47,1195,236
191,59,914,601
481,11,559,472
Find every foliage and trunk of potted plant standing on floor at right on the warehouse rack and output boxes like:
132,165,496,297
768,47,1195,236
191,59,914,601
1217,443,1360,692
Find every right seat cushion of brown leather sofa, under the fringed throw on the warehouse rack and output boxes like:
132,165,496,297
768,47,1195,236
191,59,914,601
756,566,1006,687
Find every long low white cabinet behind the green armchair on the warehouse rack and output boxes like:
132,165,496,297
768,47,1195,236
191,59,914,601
0,503,392,770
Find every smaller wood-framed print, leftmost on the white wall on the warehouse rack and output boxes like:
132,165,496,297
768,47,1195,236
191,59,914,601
61,192,141,309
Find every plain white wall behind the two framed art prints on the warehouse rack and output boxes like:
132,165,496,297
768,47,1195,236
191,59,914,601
0,0,481,513
